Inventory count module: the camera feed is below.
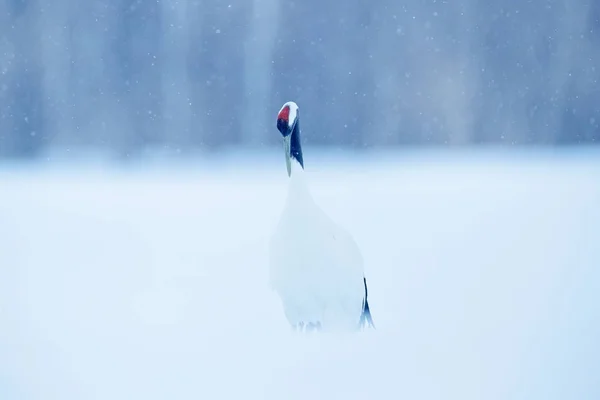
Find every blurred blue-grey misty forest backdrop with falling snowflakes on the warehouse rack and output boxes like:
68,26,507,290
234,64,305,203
0,0,600,157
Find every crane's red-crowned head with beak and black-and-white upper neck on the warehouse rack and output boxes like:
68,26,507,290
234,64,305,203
277,101,304,176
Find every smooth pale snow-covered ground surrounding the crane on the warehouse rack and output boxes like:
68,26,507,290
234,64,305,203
0,152,600,400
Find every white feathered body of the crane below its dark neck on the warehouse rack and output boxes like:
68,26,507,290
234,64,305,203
270,166,364,329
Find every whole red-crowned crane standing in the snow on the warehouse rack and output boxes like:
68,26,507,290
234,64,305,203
269,101,375,332
